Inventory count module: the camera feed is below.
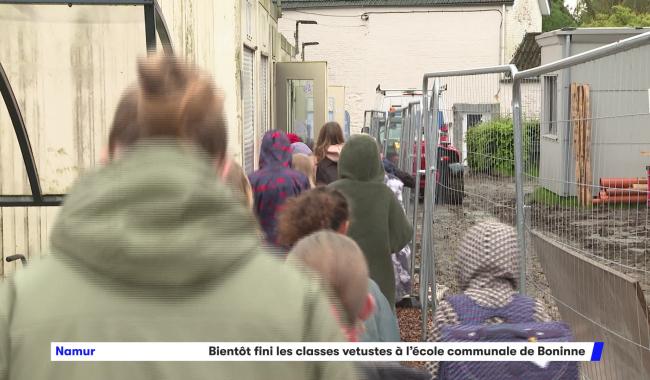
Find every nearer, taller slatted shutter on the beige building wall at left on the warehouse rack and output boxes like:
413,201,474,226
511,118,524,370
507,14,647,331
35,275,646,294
241,48,255,174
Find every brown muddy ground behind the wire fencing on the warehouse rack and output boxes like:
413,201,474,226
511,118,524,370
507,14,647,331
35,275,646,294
398,175,650,341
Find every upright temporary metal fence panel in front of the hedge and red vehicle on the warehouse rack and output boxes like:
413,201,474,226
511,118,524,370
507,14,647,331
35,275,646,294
418,66,516,339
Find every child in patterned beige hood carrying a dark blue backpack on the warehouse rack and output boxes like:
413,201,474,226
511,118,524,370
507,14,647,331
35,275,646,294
427,221,578,380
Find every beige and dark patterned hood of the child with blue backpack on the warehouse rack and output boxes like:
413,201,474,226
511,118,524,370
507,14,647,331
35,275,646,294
456,221,519,291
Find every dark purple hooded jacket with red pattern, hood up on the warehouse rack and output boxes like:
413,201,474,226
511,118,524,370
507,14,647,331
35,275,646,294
249,130,310,247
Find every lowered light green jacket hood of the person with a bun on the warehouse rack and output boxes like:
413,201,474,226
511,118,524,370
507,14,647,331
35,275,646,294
50,139,259,289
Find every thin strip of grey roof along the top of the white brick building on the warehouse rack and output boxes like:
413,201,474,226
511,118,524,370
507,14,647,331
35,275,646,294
282,0,514,10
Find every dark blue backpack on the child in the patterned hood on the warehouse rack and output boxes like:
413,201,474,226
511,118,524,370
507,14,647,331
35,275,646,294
438,294,579,380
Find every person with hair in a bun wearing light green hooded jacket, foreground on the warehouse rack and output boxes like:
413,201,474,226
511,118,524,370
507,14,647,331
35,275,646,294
0,56,357,380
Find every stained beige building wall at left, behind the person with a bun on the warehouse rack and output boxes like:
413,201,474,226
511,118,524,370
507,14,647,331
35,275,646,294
0,0,288,277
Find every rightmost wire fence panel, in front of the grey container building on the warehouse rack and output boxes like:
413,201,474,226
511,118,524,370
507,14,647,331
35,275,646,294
513,31,650,379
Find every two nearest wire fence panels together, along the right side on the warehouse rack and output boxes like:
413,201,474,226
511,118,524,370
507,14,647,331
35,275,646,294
406,33,650,379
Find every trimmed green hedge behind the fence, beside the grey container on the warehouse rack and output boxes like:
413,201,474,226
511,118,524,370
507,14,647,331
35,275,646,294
467,119,539,176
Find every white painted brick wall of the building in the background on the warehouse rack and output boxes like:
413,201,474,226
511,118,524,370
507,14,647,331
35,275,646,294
280,0,542,133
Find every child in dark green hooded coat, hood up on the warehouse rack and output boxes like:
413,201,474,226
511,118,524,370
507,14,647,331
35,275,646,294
329,135,413,308
